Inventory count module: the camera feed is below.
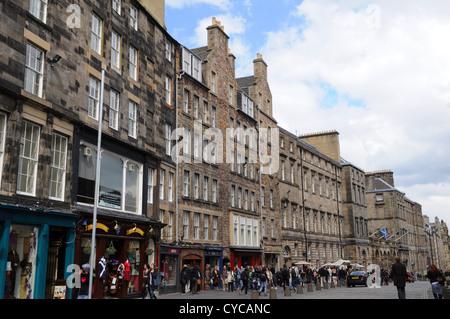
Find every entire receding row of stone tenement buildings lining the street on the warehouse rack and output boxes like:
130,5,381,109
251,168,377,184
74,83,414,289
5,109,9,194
0,0,449,299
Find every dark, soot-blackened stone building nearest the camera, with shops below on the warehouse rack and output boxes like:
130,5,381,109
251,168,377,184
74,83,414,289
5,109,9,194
0,0,176,298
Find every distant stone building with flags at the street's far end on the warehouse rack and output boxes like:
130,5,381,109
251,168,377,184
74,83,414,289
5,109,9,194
365,170,426,274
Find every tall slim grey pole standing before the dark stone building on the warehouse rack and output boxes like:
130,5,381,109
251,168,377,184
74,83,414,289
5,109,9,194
88,70,105,299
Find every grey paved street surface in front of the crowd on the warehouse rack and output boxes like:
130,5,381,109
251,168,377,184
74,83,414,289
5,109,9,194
158,281,433,300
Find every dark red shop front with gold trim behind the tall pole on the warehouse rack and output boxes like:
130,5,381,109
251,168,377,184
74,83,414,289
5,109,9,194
73,212,162,299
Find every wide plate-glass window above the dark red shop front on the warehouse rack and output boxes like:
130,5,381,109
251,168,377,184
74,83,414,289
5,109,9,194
77,142,142,213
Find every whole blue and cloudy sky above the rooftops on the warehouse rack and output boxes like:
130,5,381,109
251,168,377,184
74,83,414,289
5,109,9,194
166,0,450,228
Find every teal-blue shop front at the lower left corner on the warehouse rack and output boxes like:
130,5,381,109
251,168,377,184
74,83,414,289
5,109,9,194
0,203,78,299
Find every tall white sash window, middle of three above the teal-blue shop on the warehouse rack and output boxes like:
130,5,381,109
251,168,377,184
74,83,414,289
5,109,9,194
17,121,40,196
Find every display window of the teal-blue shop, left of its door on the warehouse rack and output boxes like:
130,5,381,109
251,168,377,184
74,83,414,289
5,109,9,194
4,224,38,299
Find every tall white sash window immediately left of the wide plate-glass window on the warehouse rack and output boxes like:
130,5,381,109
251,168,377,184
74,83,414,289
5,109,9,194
49,134,67,200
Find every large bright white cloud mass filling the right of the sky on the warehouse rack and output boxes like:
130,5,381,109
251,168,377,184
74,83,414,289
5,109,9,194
261,0,450,220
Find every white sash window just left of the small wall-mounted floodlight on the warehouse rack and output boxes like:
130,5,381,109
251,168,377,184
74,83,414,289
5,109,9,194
24,43,44,97
